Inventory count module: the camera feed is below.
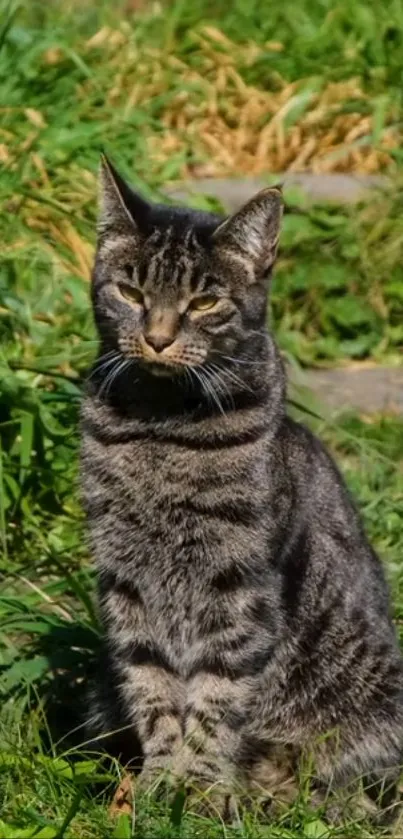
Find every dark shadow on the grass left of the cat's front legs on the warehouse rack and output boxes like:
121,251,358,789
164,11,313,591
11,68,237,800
5,619,142,770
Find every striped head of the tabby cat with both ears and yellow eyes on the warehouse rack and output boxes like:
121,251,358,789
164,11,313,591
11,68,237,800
93,158,282,375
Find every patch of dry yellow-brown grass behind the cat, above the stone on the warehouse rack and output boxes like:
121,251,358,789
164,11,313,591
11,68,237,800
86,25,402,177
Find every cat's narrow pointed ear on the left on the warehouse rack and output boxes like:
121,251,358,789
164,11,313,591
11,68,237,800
98,155,150,236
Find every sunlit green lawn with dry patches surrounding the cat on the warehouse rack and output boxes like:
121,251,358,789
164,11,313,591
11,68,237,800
0,0,403,839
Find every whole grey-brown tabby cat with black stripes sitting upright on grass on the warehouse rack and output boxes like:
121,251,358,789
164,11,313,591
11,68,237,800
81,154,403,818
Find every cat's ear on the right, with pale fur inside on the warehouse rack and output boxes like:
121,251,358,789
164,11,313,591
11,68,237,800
213,186,283,277
